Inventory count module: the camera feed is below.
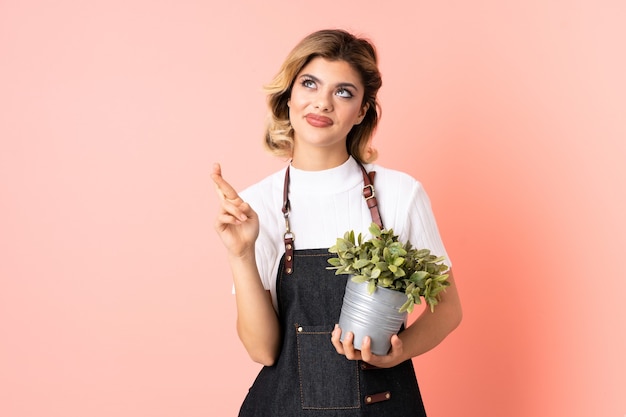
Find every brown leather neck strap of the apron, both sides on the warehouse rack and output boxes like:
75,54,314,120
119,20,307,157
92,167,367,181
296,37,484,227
282,161,384,275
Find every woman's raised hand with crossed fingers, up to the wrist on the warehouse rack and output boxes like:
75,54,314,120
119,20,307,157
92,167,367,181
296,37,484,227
211,163,259,257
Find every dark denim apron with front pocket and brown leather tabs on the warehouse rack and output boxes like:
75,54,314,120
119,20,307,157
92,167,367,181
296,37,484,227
239,164,426,417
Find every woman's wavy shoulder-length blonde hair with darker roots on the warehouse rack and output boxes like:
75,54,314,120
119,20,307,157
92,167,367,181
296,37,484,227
264,29,382,162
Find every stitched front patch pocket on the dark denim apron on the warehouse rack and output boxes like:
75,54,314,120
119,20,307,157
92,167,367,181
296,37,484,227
295,324,361,410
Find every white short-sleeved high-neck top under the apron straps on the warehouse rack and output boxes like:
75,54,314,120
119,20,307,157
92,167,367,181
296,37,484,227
240,157,452,308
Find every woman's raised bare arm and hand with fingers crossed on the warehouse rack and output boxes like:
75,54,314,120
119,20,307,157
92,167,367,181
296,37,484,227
211,164,280,366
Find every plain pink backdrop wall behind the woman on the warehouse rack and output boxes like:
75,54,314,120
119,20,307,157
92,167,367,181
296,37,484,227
0,0,626,417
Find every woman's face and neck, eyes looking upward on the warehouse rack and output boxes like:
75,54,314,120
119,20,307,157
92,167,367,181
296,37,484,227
289,57,367,160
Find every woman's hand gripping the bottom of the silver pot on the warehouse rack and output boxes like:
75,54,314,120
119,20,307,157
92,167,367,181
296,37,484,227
330,325,407,368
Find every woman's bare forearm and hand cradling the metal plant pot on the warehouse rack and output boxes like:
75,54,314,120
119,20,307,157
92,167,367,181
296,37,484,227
331,271,463,368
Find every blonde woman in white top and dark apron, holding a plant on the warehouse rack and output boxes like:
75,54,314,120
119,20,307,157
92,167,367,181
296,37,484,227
212,30,461,417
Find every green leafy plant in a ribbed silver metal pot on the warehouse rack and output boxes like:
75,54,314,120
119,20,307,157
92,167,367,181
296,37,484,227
328,223,450,355
